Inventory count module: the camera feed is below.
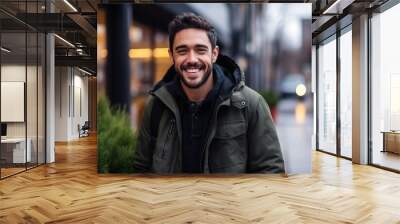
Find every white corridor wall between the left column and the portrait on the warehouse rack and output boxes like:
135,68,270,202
55,67,89,141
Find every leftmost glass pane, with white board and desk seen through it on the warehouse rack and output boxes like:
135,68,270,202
0,32,27,178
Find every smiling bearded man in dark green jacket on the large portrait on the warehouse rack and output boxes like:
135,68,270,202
134,13,285,173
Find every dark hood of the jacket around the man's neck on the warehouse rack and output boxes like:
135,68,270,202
150,54,244,92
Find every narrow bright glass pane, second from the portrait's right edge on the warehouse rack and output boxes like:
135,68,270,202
340,30,352,158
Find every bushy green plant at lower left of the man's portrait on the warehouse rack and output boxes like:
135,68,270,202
97,97,137,173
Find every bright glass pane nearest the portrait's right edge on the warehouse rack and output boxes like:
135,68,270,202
318,39,336,156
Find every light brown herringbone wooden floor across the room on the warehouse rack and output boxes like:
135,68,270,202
0,137,400,224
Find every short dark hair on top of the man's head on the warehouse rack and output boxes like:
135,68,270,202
168,13,217,51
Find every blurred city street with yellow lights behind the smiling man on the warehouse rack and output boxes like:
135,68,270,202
97,3,313,173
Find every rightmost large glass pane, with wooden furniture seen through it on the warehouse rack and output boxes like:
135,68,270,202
371,4,400,170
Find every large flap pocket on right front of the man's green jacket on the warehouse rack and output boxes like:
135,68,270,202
209,121,247,173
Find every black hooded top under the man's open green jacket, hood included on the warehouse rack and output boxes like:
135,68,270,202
154,55,241,173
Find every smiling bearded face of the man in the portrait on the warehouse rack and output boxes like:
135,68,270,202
169,28,218,89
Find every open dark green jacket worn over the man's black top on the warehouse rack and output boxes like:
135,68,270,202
134,55,285,174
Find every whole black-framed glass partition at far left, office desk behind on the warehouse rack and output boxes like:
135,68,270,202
0,1,46,178
